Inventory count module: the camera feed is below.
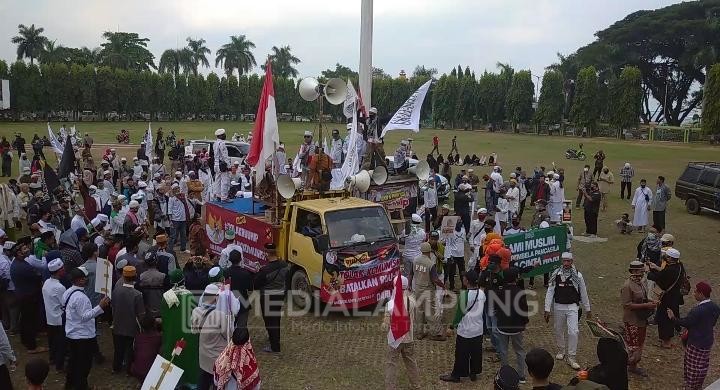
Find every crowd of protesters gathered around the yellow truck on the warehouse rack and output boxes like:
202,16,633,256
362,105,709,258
0,129,720,390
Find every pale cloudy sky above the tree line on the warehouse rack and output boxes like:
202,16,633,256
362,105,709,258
0,0,673,77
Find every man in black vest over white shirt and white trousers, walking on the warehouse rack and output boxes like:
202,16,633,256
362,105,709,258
545,252,591,370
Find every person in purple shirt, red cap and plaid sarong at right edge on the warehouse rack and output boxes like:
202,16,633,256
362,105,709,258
666,281,720,390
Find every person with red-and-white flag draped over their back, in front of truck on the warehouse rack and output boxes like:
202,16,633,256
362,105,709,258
383,275,420,389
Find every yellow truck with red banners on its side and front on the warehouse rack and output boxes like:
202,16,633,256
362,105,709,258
204,194,400,307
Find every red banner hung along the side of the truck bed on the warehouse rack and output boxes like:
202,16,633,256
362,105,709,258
205,203,273,265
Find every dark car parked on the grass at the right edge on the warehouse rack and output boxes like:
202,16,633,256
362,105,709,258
675,162,720,214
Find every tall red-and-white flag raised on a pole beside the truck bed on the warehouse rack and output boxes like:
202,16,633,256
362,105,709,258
246,61,280,183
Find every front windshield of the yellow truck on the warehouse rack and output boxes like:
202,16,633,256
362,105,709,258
325,207,395,248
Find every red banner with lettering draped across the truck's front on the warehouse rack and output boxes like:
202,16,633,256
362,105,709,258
320,244,400,307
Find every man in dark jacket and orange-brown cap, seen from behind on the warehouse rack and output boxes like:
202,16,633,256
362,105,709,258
112,265,145,374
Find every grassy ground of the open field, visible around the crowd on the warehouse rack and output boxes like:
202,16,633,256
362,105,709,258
0,122,720,389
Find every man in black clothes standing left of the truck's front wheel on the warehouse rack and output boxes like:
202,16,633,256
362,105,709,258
254,243,287,353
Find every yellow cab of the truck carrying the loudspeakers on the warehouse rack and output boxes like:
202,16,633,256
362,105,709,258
279,197,399,307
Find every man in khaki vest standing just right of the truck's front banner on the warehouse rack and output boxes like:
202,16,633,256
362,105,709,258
408,242,446,341
